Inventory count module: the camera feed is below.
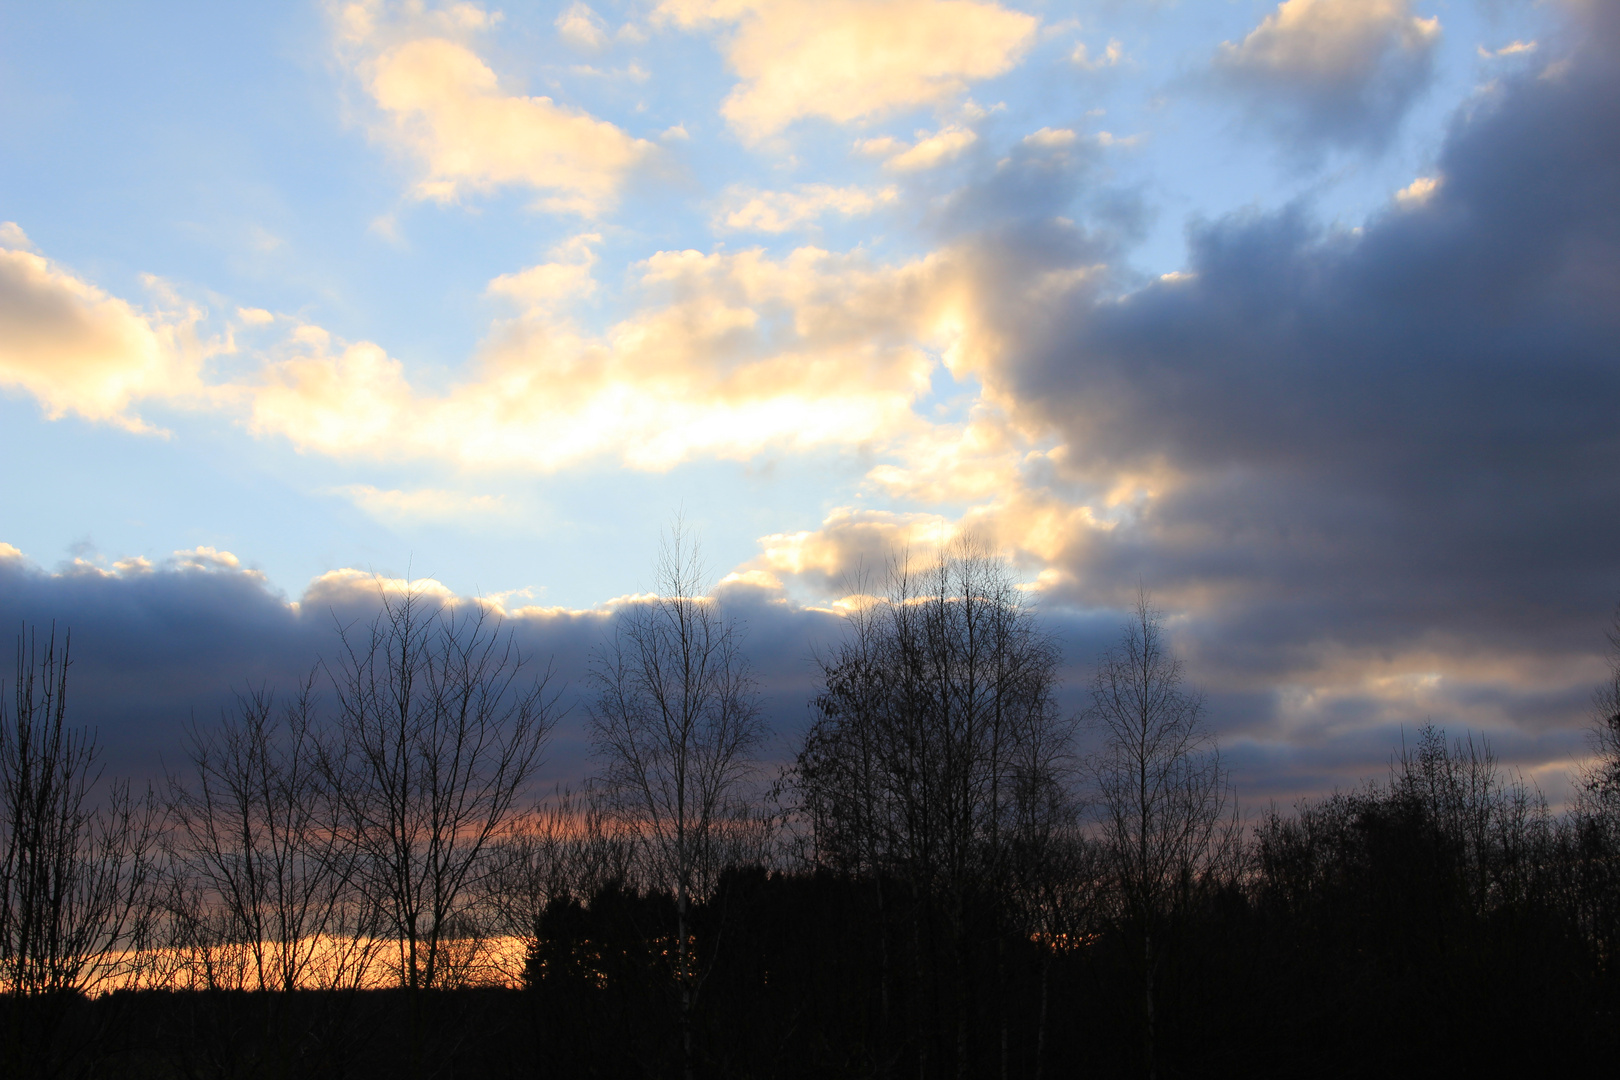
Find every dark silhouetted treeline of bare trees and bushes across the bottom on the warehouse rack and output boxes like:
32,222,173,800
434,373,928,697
0,544,1620,1080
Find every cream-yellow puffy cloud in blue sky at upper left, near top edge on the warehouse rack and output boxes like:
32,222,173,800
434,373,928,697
340,5,656,215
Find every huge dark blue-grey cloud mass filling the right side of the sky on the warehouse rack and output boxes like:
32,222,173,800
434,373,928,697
965,5,1620,790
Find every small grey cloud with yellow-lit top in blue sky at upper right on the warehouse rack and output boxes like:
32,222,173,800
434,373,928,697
1212,0,1440,154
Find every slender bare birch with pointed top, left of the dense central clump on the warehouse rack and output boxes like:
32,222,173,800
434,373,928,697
590,521,763,1077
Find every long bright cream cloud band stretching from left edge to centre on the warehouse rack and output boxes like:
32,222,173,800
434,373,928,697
0,223,1030,471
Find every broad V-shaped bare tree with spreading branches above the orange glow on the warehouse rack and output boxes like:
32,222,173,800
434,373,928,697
326,591,557,991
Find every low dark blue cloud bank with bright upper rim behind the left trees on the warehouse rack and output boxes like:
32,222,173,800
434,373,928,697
0,542,839,795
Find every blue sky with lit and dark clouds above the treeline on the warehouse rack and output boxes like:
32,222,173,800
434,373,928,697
0,0,1620,803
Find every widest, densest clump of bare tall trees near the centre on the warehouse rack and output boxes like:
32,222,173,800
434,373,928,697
795,539,1071,1072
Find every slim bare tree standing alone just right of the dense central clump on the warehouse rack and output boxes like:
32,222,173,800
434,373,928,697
1089,591,1234,1077
